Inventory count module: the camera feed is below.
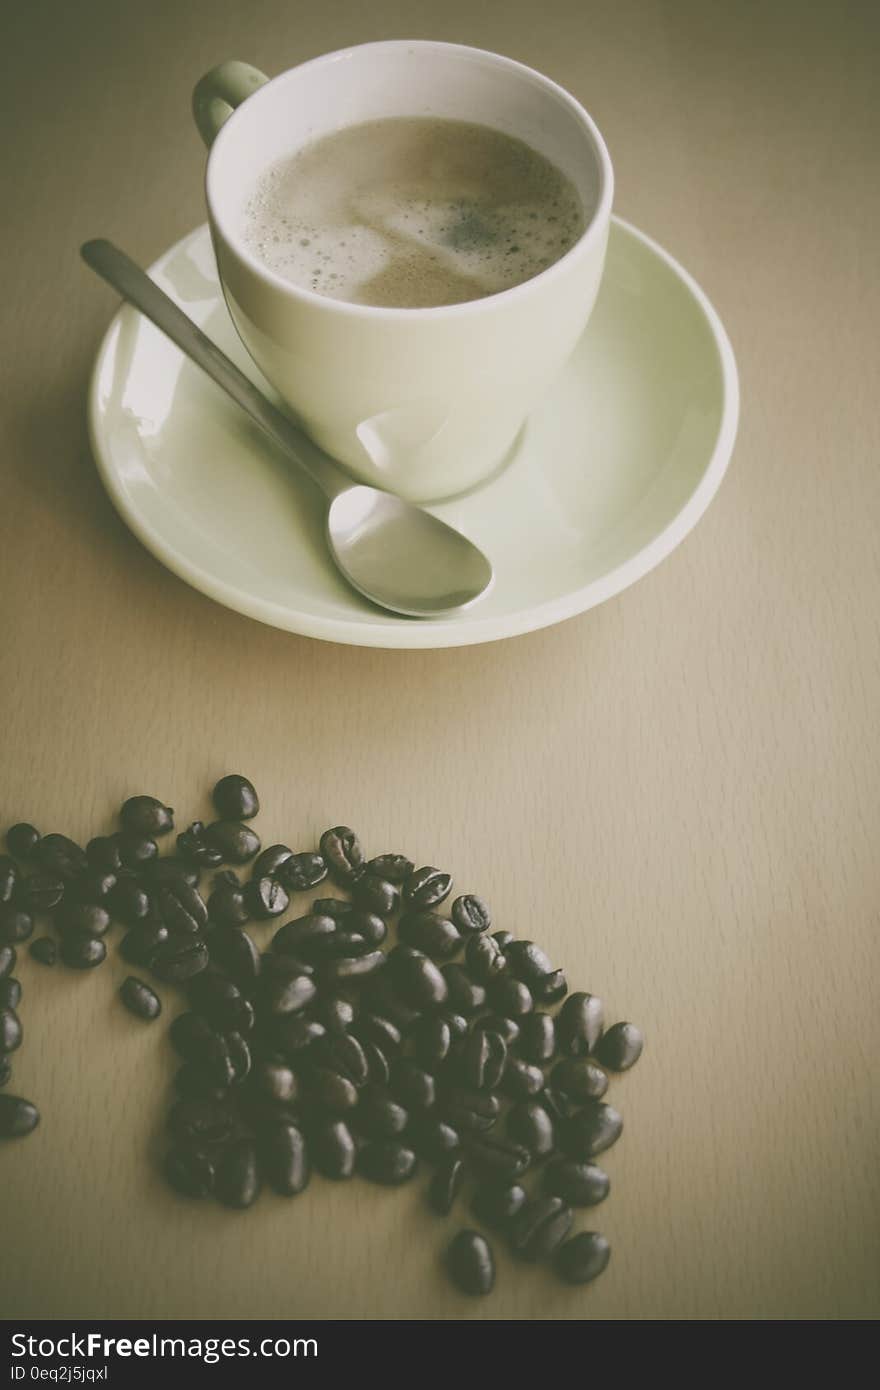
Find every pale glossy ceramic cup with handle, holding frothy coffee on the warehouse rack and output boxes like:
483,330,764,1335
193,40,613,500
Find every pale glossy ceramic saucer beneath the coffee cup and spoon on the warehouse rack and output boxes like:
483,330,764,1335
89,220,738,646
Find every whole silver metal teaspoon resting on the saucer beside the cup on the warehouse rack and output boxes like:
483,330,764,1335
81,240,494,617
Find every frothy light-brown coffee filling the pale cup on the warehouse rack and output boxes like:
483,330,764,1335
243,117,585,309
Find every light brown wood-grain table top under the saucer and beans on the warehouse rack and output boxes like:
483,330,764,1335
0,0,880,1319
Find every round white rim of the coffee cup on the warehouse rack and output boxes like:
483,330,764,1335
204,39,614,322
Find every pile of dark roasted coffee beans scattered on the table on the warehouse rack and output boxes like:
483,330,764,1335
0,774,642,1294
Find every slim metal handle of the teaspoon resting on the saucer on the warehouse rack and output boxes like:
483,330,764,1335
81,239,352,499
